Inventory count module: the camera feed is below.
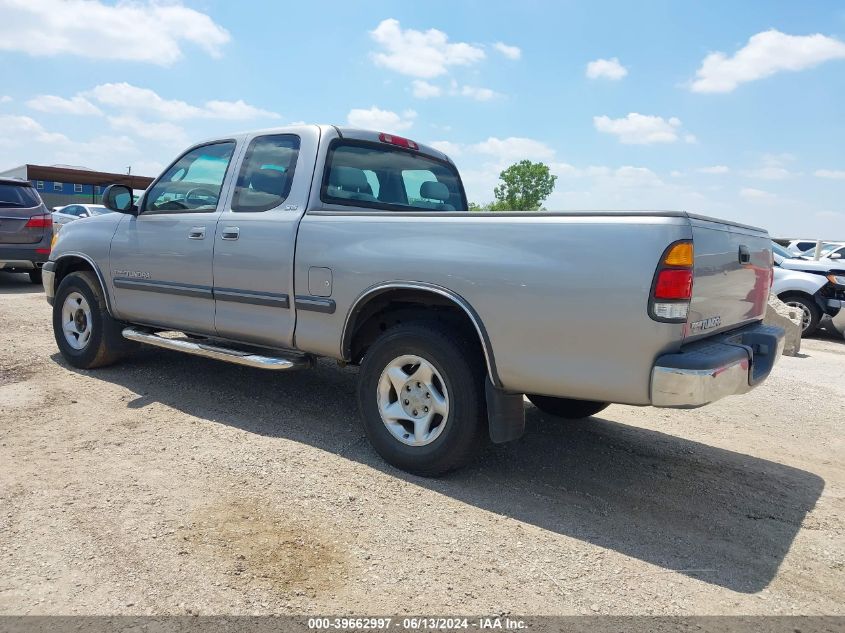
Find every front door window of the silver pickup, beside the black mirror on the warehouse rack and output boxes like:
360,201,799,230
142,141,235,213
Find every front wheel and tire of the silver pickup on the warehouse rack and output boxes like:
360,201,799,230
53,271,138,369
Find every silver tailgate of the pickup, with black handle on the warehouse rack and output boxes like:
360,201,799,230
686,217,772,340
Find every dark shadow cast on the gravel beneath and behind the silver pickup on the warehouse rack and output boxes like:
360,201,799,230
59,350,824,593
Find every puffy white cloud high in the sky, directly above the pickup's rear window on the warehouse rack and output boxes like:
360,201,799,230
370,18,485,79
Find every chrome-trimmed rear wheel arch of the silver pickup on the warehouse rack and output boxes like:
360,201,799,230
341,281,501,387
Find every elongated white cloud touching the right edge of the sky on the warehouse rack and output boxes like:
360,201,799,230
690,29,845,92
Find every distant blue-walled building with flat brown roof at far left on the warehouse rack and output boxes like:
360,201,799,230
0,165,153,208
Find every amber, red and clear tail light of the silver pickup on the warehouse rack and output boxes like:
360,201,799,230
648,240,694,323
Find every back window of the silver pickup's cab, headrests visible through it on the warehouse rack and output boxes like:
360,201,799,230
321,141,467,211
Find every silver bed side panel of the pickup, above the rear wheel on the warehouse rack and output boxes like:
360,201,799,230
295,212,691,404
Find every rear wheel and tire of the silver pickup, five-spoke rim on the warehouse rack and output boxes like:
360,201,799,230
358,321,487,477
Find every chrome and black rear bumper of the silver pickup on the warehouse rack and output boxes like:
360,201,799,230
651,323,785,409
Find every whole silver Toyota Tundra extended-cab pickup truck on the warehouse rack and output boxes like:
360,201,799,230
43,125,783,476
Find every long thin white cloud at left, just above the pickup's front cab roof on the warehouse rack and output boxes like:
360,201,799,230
82,82,279,120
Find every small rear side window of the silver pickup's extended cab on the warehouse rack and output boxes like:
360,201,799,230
232,134,299,211
